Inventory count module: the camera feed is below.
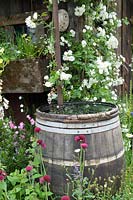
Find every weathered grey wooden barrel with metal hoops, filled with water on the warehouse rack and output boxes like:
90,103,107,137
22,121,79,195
36,103,124,194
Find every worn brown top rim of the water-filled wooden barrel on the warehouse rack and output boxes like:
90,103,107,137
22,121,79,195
36,102,118,123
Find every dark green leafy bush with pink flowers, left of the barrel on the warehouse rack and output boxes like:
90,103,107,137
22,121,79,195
0,118,34,173
